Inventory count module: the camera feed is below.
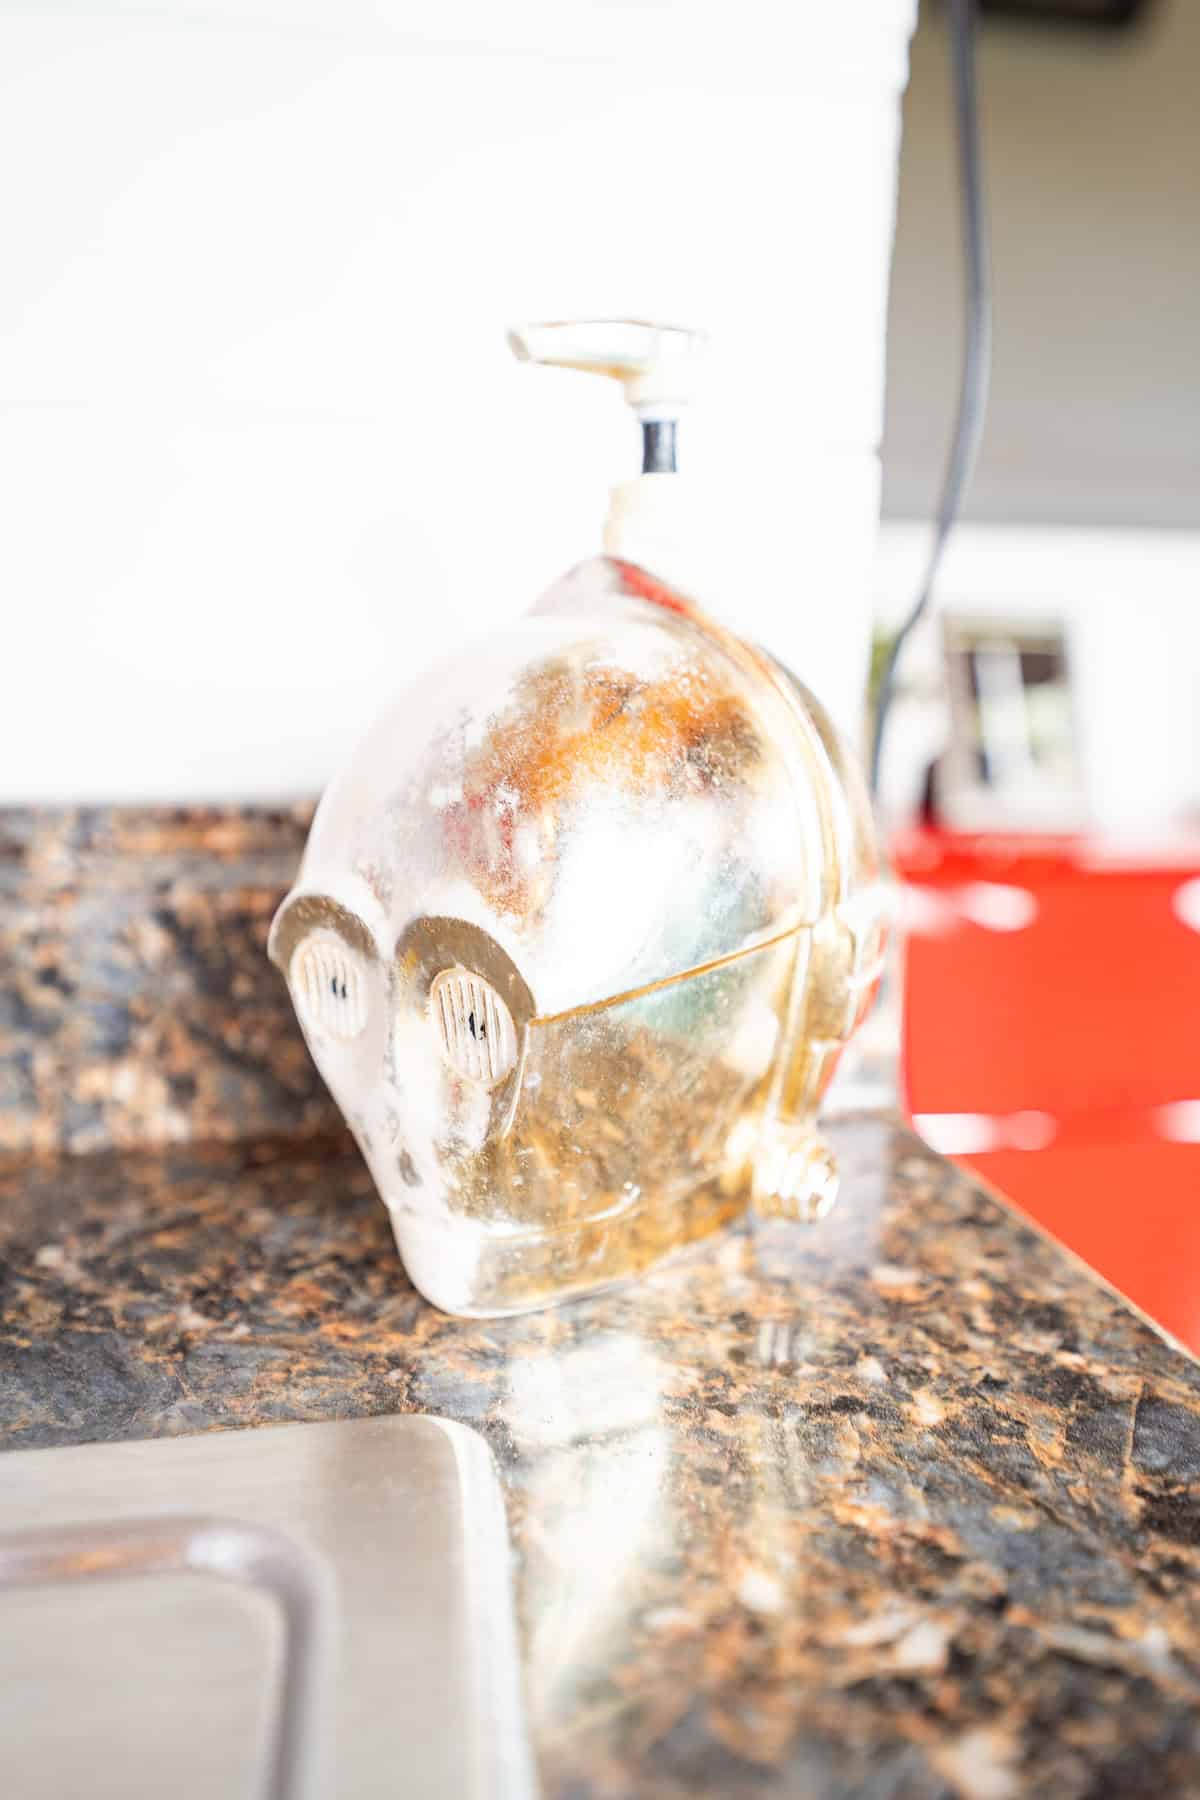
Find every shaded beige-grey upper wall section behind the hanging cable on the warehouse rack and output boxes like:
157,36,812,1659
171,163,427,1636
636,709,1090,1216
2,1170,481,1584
883,0,1200,529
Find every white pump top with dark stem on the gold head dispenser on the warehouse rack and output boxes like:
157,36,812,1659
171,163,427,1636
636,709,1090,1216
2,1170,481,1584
509,319,707,589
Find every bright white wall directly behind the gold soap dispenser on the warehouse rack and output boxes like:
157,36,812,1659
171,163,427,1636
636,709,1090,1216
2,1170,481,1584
0,0,912,803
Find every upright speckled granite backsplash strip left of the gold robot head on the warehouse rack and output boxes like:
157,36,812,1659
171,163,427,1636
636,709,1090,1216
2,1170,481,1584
0,806,336,1152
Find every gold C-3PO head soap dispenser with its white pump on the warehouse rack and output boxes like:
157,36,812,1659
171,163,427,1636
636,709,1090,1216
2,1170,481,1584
270,322,883,1316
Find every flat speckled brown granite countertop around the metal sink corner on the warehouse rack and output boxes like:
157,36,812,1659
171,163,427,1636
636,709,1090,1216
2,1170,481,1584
0,1120,1200,1800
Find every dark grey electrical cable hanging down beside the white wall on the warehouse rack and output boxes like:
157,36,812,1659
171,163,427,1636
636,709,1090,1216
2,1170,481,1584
871,0,991,796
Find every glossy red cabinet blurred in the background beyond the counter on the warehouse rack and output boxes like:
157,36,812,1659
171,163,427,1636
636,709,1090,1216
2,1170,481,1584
892,832,1200,1350
